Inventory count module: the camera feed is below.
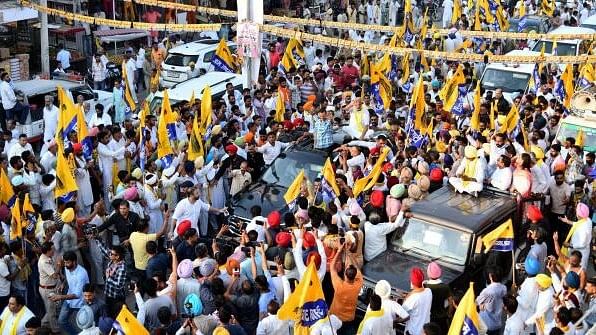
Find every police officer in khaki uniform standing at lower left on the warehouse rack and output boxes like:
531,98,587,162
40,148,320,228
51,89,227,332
37,242,60,333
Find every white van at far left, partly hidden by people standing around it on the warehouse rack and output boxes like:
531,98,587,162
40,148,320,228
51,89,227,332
1,79,113,143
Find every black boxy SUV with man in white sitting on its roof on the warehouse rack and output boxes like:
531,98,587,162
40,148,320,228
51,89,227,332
358,186,524,310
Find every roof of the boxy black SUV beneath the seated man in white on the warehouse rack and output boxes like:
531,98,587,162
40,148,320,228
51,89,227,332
411,186,517,233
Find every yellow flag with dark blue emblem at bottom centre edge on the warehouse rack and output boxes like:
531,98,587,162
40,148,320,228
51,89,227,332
277,262,328,335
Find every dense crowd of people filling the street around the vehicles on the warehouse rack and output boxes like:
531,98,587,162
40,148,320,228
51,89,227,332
0,0,596,335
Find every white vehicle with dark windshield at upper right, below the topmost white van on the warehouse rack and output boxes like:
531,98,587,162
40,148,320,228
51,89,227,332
480,50,540,101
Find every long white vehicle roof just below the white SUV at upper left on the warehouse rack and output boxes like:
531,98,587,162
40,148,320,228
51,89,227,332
155,71,243,101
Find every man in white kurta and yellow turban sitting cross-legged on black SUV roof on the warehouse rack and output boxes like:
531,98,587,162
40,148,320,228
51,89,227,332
449,145,485,195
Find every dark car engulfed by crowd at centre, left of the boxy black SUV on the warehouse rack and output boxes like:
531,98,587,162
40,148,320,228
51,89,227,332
229,146,327,230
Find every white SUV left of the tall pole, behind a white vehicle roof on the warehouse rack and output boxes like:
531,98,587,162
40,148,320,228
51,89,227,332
161,39,236,88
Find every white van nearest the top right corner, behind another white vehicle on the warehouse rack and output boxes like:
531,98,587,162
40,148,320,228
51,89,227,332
532,26,596,56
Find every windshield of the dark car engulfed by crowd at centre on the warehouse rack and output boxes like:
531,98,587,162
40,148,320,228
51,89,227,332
262,154,323,187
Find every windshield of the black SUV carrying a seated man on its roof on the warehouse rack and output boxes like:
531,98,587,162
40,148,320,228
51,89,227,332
391,218,471,265
